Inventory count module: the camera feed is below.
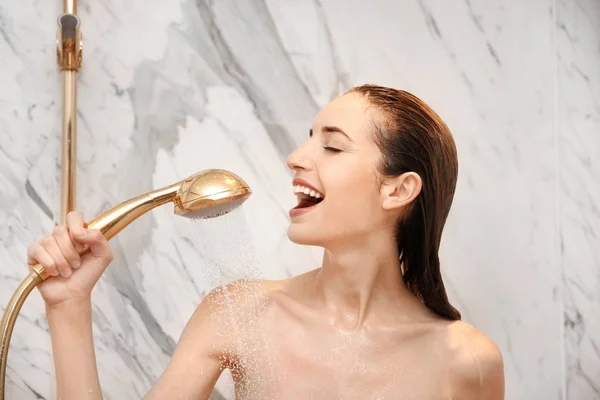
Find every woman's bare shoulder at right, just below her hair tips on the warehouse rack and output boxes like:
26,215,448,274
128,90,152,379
448,321,504,400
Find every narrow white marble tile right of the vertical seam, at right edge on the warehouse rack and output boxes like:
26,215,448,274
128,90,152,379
557,1,600,400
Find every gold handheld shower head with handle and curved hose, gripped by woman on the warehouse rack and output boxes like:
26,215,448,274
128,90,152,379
0,169,252,400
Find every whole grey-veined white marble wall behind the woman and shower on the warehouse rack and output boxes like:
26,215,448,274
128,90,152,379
0,0,600,400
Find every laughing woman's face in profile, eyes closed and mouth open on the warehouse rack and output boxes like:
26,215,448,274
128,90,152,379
287,93,389,247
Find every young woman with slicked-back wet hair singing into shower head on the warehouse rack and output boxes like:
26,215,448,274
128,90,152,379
28,85,504,400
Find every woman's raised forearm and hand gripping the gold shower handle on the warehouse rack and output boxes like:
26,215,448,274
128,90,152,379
27,212,113,400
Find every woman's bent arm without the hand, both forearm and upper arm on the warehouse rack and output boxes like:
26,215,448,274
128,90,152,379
46,290,226,400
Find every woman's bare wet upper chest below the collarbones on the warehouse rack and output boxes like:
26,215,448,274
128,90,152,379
230,321,452,400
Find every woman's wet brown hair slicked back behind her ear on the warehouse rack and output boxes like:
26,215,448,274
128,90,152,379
349,85,461,320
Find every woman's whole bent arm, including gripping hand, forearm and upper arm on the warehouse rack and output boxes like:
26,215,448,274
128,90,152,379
27,212,229,400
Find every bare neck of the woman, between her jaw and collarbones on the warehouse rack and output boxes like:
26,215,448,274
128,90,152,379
315,234,418,329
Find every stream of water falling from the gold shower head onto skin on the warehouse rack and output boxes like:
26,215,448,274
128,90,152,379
183,207,277,400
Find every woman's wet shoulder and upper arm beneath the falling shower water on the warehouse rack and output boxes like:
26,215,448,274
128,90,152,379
146,280,282,399
